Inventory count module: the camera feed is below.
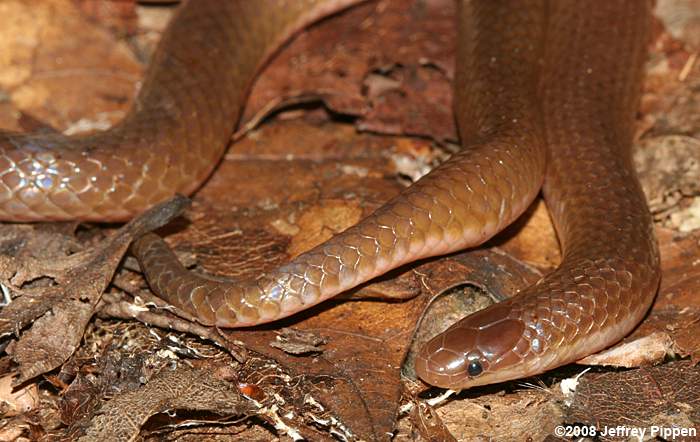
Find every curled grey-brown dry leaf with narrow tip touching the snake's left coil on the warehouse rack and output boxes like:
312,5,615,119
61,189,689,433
0,197,188,384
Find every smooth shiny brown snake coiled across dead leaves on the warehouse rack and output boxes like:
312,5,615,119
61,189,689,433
0,0,659,388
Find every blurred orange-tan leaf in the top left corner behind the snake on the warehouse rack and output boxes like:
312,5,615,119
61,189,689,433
0,0,141,133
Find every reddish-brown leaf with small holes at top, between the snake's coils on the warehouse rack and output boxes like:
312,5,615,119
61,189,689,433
243,0,456,140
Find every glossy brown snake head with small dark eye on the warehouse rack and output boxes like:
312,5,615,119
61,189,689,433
415,301,525,390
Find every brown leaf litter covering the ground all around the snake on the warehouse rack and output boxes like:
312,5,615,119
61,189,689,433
0,0,700,440
